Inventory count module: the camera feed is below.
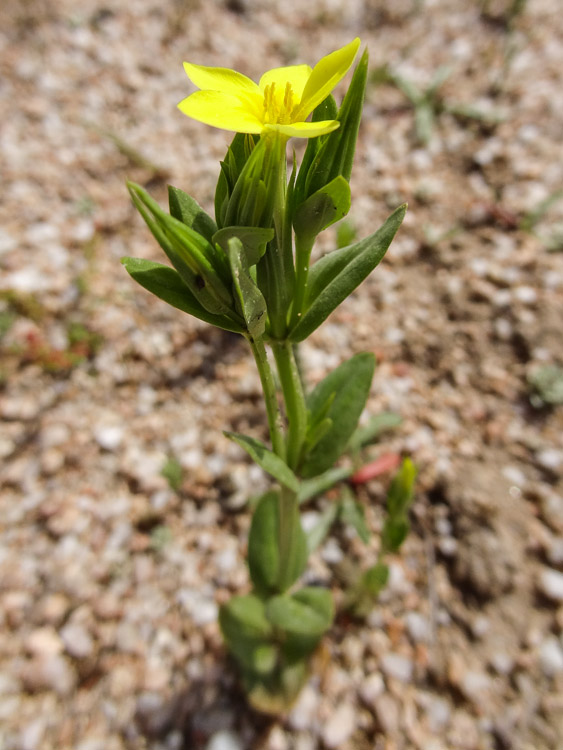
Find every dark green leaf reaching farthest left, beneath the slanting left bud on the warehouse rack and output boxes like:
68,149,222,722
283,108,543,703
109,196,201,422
121,257,245,333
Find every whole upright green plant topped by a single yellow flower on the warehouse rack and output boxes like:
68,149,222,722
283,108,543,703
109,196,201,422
122,39,416,713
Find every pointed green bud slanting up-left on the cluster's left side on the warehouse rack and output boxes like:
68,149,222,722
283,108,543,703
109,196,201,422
127,182,234,315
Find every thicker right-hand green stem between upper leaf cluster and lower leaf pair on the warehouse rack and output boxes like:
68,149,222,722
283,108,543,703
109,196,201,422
272,341,307,471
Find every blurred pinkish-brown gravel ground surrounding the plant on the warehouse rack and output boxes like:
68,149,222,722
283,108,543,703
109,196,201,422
0,0,563,750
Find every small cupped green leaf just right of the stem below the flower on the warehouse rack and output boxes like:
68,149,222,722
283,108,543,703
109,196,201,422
293,176,351,244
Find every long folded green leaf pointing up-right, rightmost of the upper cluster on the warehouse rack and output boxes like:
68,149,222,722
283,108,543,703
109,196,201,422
289,203,407,341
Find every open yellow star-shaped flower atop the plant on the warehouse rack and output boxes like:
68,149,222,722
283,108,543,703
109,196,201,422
178,38,360,138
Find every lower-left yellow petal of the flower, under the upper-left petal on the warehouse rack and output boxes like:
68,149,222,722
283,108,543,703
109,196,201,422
178,91,263,133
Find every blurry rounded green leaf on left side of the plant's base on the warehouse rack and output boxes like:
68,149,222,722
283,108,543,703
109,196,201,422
219,594,277,672
